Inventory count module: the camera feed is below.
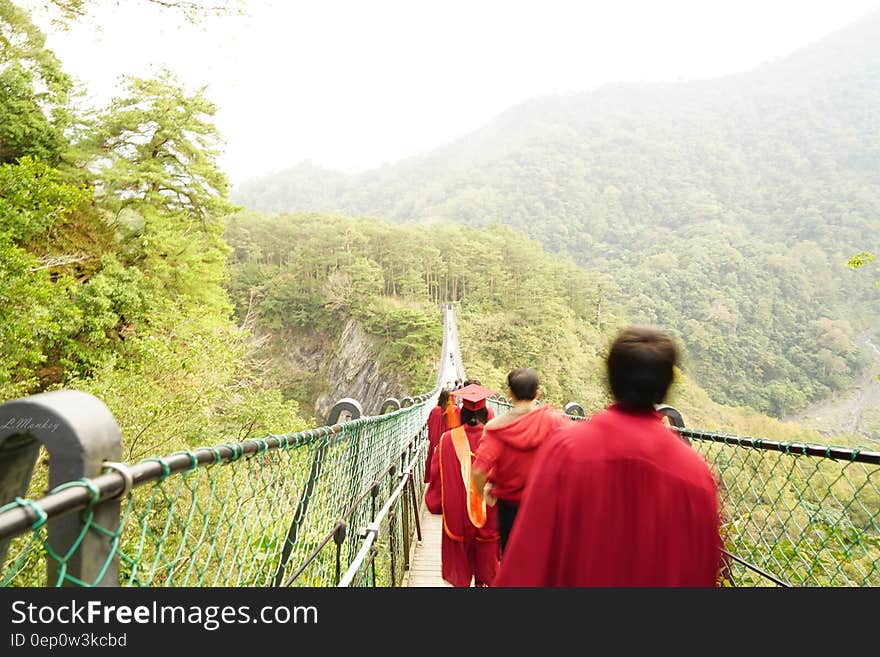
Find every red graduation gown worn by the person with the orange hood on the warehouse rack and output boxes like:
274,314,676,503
425,425,499,586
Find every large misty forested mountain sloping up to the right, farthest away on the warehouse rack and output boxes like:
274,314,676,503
234,14,880,415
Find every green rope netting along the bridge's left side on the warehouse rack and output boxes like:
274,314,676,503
0,403,427,587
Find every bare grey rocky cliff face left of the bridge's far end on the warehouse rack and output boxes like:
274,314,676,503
273,320,412,424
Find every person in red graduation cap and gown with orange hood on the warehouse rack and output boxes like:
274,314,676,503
425,384,499,586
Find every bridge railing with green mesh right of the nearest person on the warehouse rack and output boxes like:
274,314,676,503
678,429,880,586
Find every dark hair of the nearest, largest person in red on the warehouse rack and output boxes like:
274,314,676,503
605,326,678,409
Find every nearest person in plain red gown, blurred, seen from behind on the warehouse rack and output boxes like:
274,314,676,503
495,327,723,587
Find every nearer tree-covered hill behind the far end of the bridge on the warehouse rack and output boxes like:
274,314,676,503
227,211,864,443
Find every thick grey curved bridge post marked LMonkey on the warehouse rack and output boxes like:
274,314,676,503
0,390,122,586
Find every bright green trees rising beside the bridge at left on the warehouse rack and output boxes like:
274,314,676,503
0,0,303,458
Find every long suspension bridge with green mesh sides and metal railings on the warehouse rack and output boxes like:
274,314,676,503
0,307,880,587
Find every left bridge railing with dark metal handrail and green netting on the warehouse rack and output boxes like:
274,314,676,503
0,395,431,586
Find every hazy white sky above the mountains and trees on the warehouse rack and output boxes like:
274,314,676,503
24,0,880,182
